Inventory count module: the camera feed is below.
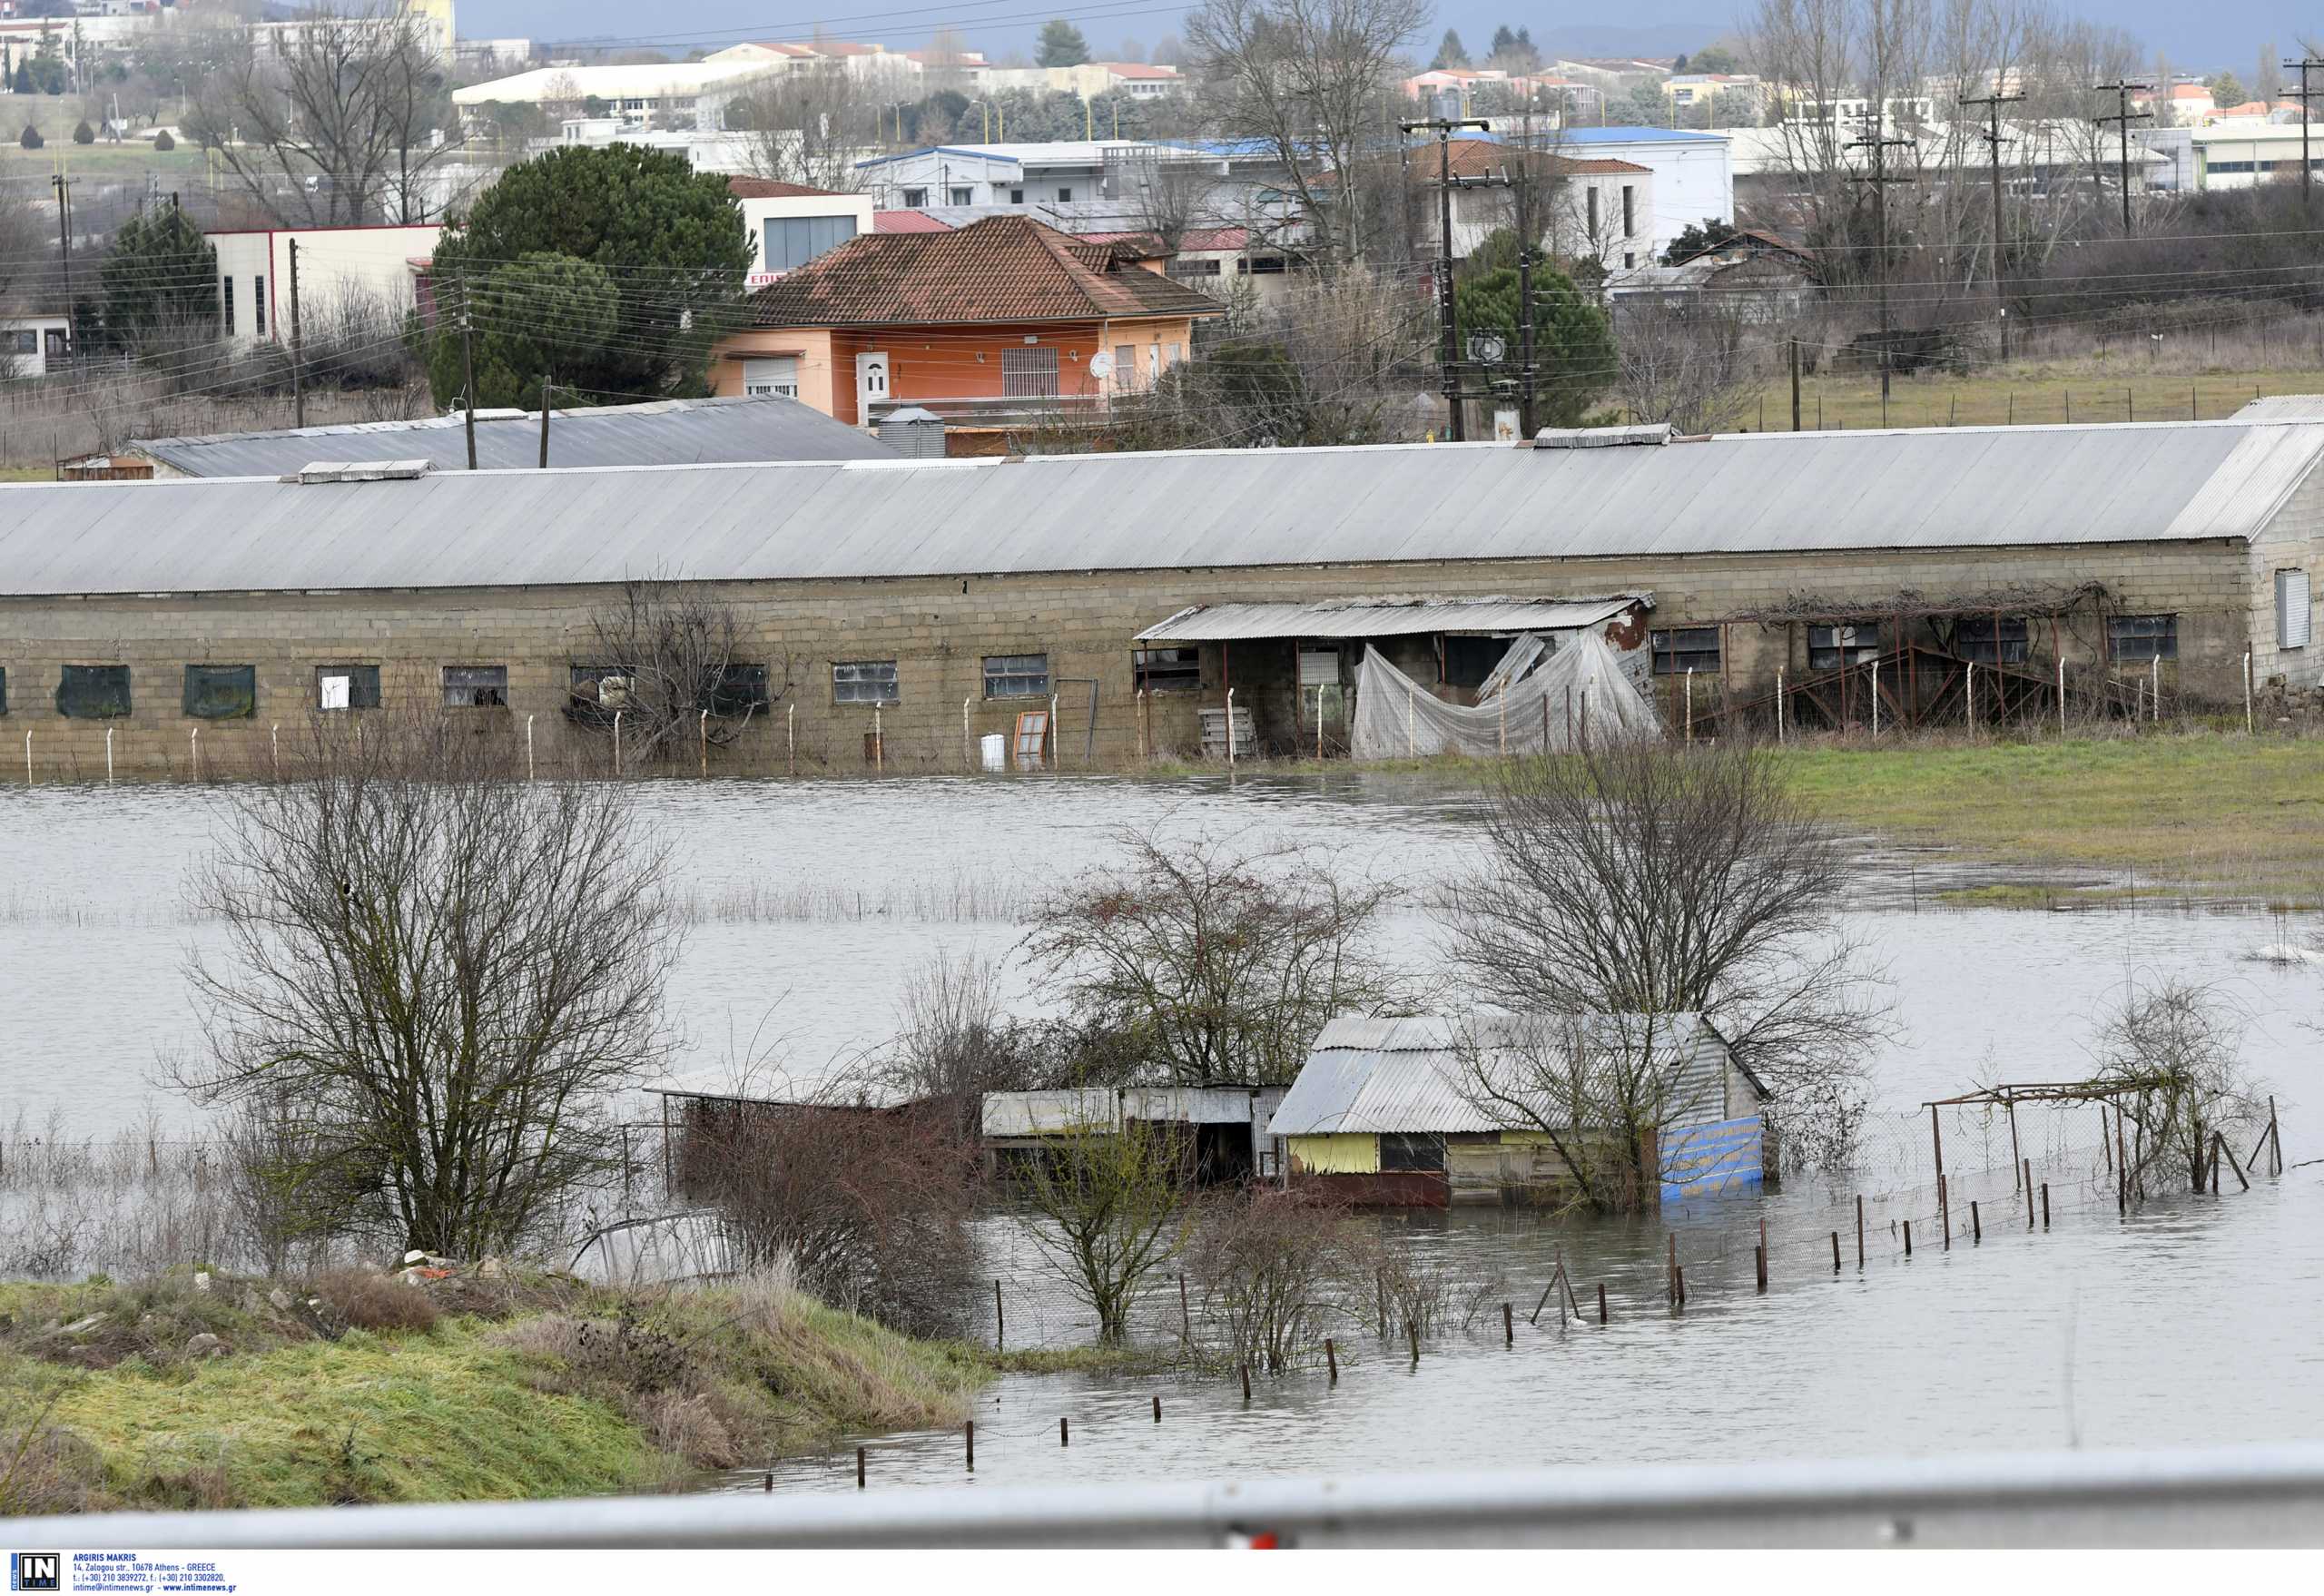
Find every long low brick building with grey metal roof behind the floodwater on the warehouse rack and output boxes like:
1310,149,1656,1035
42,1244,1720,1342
0,416,2324,781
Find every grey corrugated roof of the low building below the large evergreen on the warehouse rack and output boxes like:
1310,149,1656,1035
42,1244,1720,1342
130,398,897,477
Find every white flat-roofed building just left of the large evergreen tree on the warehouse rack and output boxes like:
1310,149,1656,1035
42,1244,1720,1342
202,223,444,346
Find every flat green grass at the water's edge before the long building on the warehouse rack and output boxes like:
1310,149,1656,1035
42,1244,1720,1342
1146,732,2324,909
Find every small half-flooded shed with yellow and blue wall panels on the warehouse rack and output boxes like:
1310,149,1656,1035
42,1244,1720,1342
1266,1015,1764,1208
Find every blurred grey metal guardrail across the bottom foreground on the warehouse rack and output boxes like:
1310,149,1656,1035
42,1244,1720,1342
14,1443,2324,1550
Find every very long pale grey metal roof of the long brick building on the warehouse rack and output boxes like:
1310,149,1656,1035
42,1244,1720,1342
0,420,2324,595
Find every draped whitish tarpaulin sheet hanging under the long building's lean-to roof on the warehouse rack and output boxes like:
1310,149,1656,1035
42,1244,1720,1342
1348,632,1661,760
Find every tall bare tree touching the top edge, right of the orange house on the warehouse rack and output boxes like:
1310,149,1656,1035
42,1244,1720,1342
1186,0,1432,261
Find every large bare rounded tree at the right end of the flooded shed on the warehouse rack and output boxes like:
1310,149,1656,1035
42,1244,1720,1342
1439,741,1892,1206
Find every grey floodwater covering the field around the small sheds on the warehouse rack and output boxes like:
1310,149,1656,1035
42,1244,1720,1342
0,773,2324,1492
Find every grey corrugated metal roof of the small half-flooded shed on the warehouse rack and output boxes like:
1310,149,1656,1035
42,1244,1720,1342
1266,1013,1703,1136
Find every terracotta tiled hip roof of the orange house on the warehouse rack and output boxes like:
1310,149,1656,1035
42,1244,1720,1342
751,216,1223,328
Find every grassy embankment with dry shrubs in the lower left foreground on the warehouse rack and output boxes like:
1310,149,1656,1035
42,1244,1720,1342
0,1271,995,1517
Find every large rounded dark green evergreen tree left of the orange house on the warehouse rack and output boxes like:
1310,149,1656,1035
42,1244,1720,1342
430,144,751,399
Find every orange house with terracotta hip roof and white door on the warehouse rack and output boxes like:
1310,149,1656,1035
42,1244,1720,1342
711,216,1223,429
